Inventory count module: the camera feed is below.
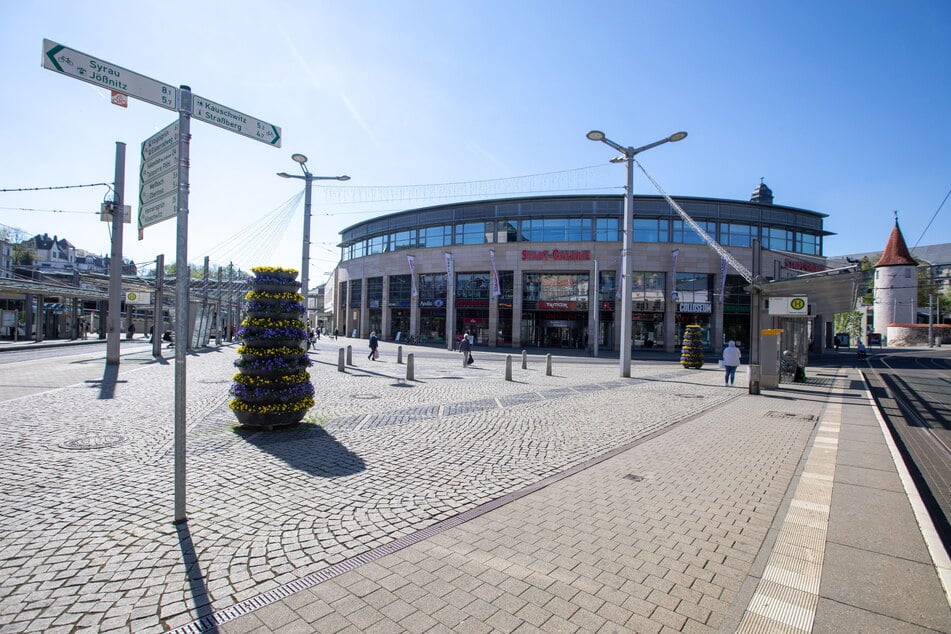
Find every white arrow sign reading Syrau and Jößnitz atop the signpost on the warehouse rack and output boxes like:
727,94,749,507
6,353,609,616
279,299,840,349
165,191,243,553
42,39,178,111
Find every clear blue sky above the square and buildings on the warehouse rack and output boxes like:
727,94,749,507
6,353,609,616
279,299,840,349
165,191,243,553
0,0,951,284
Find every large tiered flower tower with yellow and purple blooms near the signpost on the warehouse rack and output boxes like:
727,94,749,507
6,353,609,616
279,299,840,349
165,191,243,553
229,266,314,429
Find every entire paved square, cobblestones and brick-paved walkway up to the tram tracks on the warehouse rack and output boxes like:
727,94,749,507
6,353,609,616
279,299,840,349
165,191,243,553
0,338,951,633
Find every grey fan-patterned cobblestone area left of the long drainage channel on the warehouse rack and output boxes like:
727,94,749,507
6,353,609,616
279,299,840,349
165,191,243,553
0,342,760,632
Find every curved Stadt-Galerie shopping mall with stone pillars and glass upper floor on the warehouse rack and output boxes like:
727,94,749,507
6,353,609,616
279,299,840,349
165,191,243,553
325,184,830,351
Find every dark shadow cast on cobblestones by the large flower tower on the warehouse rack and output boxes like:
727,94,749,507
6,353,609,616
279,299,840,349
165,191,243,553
234,423,366,478
